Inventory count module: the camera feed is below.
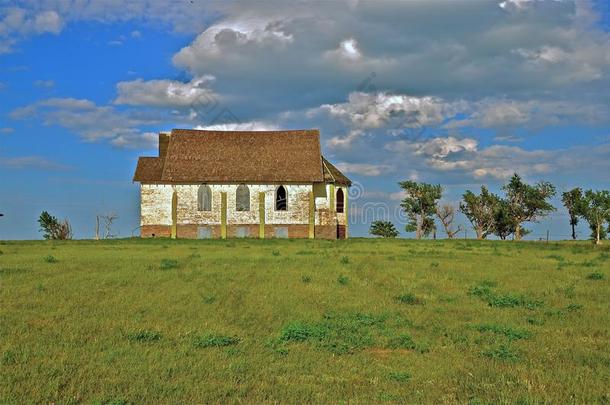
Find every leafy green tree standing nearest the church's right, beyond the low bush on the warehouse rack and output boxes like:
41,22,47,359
398,180,443,239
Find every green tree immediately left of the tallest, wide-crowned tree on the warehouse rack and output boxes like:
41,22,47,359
460,186,500,239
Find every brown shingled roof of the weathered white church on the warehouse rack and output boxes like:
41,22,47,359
133,129,349,184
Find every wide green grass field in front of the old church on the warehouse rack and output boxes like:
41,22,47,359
0,239,610,404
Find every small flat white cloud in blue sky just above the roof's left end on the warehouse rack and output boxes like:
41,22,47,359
115,76,218,109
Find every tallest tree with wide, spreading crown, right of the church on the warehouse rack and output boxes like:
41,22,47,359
502,173,555,240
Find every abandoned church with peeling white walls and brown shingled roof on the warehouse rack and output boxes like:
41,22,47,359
133,129,351,239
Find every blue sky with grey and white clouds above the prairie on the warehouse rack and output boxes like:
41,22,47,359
0,0,610,239
